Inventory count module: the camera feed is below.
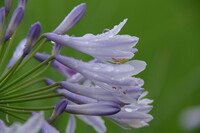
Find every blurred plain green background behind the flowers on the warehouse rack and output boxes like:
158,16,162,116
1,0,200,133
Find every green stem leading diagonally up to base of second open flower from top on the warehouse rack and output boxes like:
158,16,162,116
2,56,55,90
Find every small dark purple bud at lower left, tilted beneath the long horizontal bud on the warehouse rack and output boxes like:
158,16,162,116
48,100,68,123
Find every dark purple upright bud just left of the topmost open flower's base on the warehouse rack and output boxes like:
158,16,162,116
24,22,42,55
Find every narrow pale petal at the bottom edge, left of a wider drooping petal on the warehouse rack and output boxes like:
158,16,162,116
66,115,76,133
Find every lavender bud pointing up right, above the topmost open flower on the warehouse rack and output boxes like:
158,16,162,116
53,3,86,34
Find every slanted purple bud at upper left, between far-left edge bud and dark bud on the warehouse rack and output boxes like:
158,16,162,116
3,7,24,40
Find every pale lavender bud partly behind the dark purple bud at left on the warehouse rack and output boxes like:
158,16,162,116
7,39,26,68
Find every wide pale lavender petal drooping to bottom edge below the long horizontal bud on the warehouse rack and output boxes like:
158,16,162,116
77,115,106,133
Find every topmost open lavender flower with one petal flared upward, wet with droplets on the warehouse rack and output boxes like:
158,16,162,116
45,19,138,62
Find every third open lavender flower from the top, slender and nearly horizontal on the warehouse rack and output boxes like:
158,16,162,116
61,82,143,104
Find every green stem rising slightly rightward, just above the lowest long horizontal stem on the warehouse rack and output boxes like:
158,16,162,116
0,94,64,104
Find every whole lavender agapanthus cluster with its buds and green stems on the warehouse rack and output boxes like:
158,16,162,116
0,0,152,133
